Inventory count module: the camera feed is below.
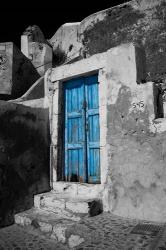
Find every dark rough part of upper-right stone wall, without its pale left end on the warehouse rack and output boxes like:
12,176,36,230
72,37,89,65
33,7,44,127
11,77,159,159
82,0,166,81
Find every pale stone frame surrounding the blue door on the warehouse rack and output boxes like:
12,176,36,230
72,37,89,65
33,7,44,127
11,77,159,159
45,53,109,189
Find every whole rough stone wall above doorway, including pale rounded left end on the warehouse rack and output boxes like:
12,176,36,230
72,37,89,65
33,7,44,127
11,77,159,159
50,0,166,85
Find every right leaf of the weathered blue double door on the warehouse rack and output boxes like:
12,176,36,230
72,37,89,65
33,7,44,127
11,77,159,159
85,75,100,183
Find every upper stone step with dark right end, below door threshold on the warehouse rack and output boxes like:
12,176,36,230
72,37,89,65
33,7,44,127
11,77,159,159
34,191,102,216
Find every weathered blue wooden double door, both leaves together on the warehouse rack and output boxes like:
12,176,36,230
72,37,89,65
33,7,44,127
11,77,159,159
64,75,100,183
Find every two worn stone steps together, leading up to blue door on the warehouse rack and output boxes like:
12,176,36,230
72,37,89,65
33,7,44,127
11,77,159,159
15,191,102,244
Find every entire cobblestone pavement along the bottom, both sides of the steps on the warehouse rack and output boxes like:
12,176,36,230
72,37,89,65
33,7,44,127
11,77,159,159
0,213,166,250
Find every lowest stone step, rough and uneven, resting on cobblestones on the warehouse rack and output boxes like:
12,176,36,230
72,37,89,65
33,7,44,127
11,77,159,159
15,208,76,244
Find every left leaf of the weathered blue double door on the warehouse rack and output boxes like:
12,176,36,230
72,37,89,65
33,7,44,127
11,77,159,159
65,79,86,182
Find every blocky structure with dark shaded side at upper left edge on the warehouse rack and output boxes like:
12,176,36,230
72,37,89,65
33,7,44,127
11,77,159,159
0,42,40,100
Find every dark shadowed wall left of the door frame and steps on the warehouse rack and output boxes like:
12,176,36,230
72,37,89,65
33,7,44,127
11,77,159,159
0,101,50,227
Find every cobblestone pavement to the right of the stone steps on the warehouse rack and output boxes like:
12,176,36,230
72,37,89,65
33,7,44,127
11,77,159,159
65,213,166,250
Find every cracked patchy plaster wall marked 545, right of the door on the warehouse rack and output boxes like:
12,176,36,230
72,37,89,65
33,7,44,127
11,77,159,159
103,45,166,222
